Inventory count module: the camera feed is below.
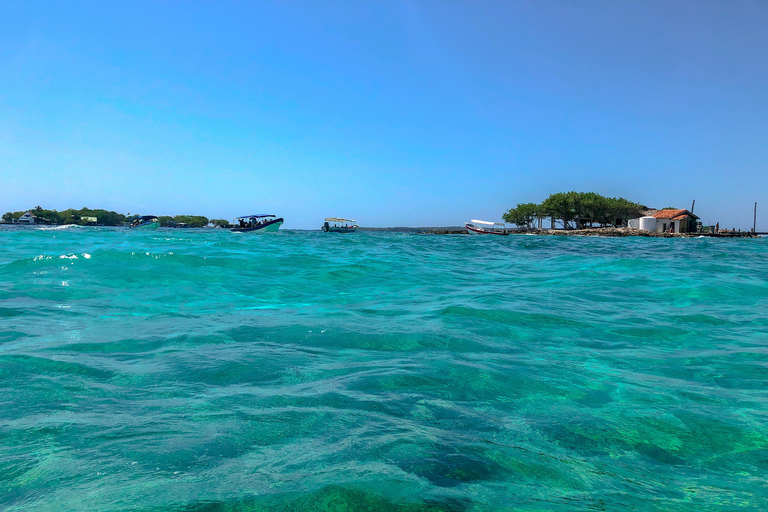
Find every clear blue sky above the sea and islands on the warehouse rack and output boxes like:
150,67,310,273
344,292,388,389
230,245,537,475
0,0,768,230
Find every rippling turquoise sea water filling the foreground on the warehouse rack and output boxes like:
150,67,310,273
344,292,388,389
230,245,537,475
0,227,768,512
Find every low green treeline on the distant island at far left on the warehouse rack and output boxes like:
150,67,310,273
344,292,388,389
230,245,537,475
3,206,229,228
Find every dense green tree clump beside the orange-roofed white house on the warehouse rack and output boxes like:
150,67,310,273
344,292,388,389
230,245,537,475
502,192,646,229
